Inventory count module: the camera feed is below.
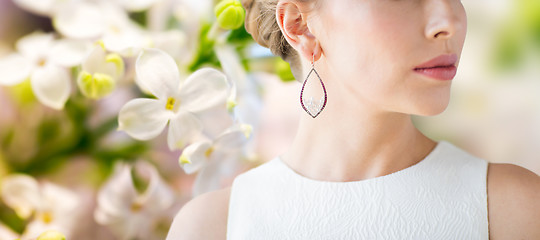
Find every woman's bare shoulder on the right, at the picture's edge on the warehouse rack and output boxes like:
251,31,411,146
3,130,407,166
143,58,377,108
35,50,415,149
487,163,540,239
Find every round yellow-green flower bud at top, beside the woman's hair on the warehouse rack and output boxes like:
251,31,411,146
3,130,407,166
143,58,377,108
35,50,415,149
214,0,246,30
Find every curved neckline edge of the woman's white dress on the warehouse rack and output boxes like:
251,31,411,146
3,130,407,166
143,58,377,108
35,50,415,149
275,140,449,185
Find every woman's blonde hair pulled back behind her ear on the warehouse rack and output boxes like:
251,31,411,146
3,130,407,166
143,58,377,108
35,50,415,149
242,0,309,80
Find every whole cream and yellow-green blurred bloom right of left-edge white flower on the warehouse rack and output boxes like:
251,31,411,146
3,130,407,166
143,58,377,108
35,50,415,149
77,44,124,99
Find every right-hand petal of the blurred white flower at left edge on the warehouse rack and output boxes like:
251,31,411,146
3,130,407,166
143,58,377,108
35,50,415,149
49,39,91,67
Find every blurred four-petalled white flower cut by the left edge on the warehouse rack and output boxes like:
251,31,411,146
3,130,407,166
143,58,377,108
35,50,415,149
0,32,89,109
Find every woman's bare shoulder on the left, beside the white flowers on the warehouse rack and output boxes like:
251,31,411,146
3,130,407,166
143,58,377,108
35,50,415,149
167,187,231,240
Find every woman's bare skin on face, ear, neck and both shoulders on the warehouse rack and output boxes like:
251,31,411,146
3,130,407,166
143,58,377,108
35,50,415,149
170,0,540,239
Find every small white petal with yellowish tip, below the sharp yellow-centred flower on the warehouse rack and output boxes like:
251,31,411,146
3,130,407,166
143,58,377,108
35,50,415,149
179,141,212,174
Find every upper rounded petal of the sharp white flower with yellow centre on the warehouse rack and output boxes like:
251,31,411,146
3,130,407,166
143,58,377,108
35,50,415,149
136,48,180,99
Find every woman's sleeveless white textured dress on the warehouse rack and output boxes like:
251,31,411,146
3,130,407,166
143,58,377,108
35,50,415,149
227,140,489,240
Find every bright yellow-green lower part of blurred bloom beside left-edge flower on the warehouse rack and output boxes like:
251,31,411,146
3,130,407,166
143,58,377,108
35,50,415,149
77,71,116,99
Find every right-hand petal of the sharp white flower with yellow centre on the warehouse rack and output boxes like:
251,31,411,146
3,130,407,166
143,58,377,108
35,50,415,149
180,68,230,112
